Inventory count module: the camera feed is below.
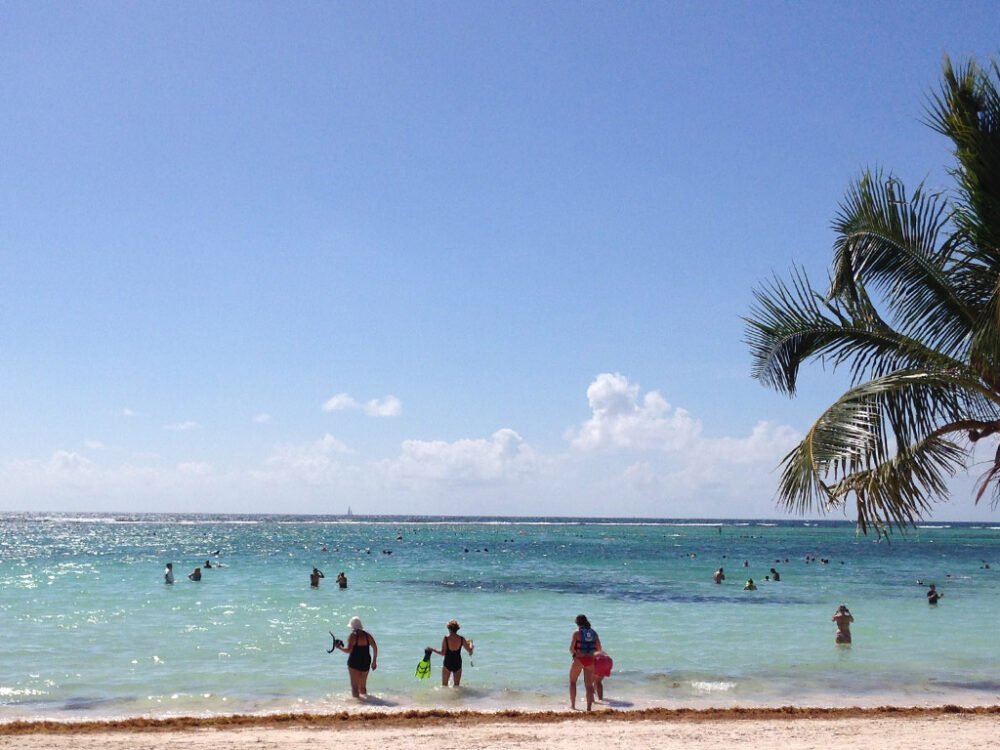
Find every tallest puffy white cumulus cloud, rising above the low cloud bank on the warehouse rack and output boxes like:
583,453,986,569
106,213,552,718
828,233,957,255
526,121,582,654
570,373,702,451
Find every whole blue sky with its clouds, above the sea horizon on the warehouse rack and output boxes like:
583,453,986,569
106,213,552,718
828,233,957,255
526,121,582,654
0,2,1000,520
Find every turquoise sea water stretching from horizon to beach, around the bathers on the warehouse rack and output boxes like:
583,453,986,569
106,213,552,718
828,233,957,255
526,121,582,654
0,515,1000,720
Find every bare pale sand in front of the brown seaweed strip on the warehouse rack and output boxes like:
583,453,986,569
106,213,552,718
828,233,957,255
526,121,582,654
0,713,1000,750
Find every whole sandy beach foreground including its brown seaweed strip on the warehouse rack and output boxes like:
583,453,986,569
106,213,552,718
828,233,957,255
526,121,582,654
0,706,1000,750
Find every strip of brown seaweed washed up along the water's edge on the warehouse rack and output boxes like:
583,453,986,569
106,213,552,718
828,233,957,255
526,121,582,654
0,704,1000,737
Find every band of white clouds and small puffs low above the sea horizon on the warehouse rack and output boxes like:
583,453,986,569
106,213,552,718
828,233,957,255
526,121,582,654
0,373,798,517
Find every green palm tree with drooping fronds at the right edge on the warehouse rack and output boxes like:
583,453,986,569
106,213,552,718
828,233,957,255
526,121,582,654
746,58,1000,535
